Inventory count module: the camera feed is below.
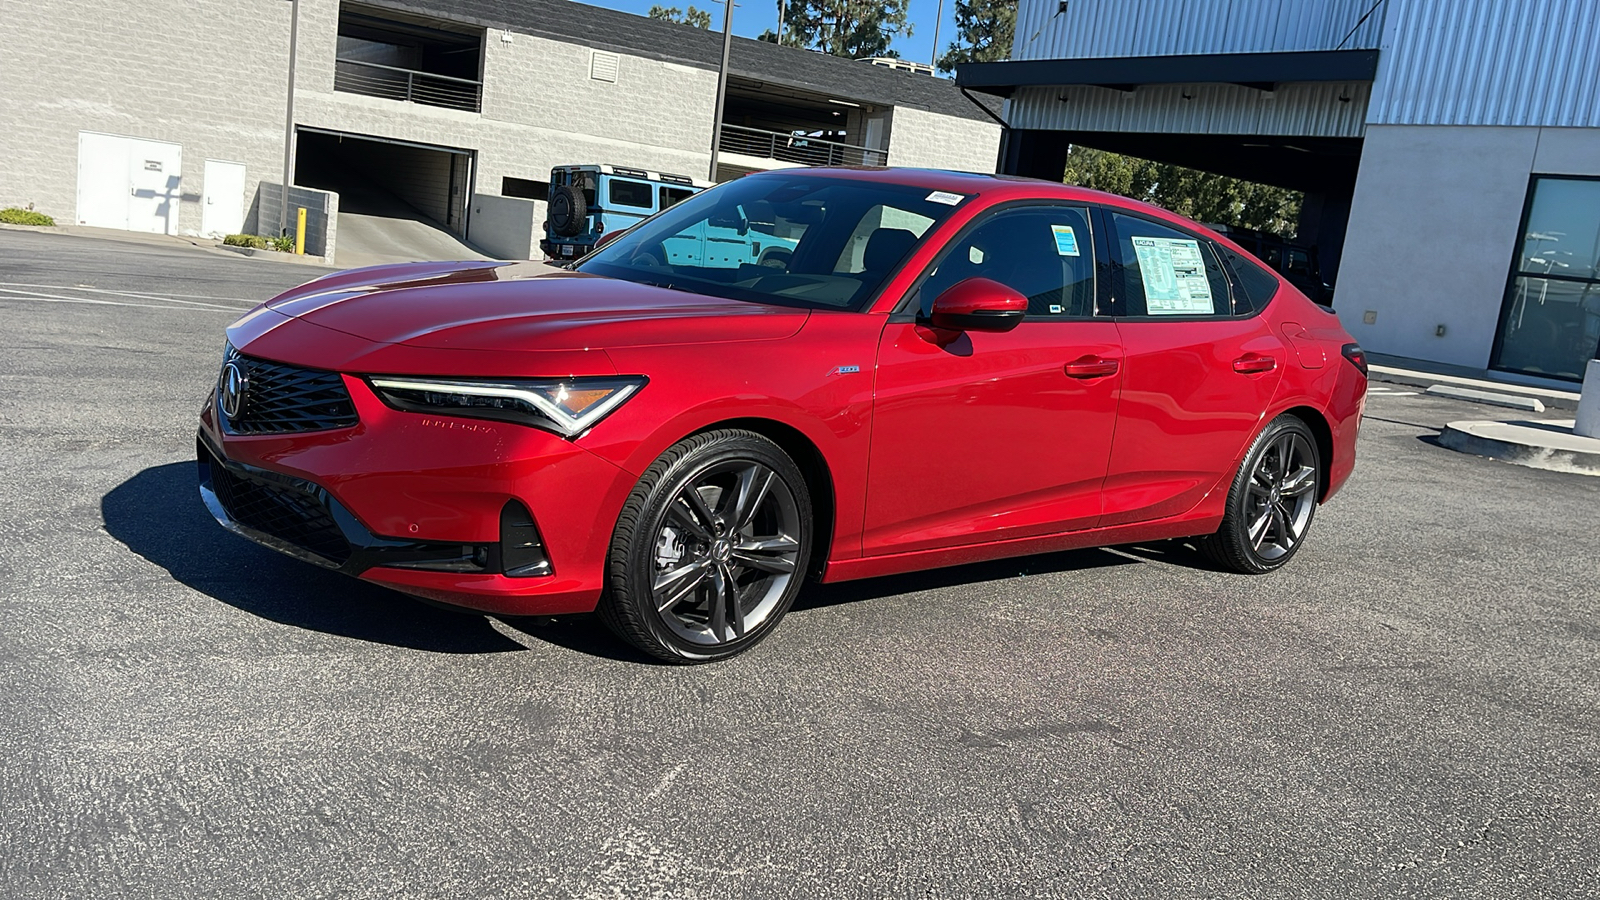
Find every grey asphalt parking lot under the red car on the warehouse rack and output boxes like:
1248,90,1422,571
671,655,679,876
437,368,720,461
0,231,1600,898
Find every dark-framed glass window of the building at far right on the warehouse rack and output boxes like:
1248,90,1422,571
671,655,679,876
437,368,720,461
1494,176,1600,381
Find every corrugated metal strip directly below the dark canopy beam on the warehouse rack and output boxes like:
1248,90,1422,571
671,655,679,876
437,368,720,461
1006,82,1371,138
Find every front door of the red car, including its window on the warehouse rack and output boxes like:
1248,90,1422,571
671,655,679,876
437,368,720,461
862,205,1122,556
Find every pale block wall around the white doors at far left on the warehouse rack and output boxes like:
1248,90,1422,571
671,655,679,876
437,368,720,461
0,0,294,232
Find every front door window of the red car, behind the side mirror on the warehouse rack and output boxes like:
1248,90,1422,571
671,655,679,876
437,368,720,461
918,207,1094,322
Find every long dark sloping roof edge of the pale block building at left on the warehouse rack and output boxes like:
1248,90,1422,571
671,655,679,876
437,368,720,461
363,0,1000,122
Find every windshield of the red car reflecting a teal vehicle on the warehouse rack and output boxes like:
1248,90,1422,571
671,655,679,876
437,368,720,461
576,173,962,309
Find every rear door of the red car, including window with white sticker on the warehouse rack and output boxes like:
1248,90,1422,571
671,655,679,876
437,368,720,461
1099,208,1288,525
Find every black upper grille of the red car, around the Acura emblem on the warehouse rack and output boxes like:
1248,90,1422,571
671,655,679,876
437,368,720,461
218,351,357,434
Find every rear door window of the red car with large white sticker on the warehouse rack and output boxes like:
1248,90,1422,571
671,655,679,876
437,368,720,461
1112,211,1234,317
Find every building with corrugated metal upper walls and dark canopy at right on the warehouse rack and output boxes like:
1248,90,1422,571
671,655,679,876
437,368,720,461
957,0,1600,384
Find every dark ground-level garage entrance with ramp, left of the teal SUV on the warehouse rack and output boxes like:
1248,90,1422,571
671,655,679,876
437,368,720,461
294,128,472,237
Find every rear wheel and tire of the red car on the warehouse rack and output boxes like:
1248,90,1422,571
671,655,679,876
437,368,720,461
1200,415,1322,575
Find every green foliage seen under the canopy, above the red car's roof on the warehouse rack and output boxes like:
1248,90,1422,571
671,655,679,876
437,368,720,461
1062,146,1304,237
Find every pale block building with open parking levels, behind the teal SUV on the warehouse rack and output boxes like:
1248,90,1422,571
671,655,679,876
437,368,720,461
0,0,1000,256
